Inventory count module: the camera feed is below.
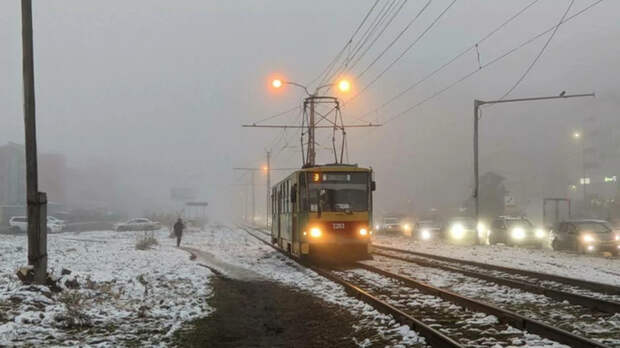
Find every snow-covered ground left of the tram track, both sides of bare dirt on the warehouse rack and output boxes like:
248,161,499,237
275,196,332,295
0,225,424,347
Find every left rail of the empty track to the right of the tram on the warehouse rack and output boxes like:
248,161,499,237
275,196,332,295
374,252,620,314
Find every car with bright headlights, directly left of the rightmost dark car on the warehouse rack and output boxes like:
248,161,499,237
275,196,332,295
488,216,548,247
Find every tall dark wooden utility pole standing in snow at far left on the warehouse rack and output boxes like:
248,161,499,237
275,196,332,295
22,0,47,284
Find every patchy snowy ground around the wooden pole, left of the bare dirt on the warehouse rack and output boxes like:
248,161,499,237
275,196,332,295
0,231,212,346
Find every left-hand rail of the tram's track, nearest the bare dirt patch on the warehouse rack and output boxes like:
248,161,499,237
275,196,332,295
240,226,463,348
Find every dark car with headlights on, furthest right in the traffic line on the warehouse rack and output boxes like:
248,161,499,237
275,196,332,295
551,219,620,255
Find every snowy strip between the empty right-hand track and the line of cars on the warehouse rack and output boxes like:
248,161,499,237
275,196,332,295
373,235,620,286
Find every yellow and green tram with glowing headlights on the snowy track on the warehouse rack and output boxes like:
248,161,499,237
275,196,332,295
271,163,375,261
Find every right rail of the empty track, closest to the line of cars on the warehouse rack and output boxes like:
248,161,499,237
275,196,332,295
372,244,620,295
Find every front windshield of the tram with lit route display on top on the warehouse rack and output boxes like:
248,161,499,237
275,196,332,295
308,172,368,212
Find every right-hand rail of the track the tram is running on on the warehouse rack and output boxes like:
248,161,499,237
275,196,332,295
356,263,607,348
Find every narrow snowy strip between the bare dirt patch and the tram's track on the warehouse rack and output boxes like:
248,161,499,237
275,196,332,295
178,226,424,347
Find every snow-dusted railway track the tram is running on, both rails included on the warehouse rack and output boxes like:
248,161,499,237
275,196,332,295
244,227,607,347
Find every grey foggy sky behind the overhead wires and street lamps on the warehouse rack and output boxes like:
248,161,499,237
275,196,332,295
0,0,620,219
